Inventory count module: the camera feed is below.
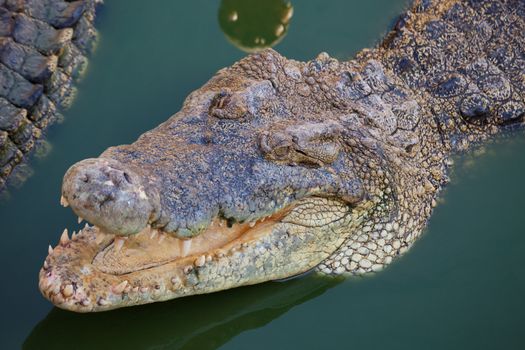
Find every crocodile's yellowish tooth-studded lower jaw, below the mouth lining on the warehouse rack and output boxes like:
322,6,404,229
39,198,359,312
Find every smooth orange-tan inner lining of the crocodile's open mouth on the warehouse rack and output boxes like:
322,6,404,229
93,208,290,275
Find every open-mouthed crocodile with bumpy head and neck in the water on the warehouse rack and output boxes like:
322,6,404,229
39,0,525,312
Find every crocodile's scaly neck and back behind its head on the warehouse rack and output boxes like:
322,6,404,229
319,0,525,274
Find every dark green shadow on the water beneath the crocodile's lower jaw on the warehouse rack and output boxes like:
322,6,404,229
23,275,341,350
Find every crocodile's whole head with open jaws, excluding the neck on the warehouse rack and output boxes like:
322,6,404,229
40,50,388,312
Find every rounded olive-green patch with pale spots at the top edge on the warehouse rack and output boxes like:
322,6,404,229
219,0,293,52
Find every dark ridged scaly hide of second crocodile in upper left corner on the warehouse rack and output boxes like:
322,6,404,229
0,0,100,191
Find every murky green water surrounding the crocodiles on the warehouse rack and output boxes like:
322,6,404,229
0,0,525,349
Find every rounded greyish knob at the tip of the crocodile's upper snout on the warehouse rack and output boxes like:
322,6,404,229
62,158,160,235
